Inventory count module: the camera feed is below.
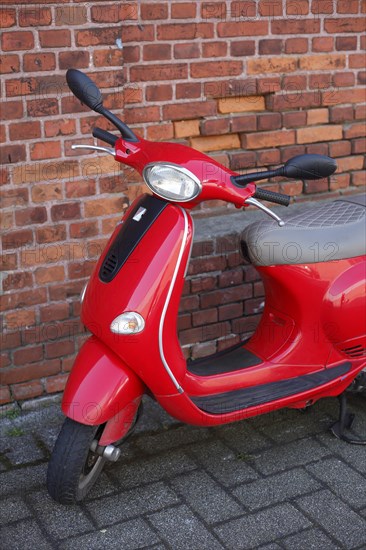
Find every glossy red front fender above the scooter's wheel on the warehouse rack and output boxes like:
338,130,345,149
62,336,145,426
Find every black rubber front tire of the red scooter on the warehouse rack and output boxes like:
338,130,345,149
47,418,106,504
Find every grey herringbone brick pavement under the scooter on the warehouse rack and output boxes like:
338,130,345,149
0,395,366,550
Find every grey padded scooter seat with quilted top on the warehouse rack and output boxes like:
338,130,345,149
241,195,366,266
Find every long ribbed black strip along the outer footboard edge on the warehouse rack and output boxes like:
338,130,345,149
190,362,352,414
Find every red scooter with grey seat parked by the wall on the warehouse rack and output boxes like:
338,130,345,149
47,69,366,504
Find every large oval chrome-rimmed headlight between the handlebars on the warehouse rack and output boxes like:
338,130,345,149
142,162,202,202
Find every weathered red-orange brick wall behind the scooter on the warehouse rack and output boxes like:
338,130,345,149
0,0,366,403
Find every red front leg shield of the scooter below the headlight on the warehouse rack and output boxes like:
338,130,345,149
82,196,193,395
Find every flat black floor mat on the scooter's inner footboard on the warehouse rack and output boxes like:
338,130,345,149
187,343,262,376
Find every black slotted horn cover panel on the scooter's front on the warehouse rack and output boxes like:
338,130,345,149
99,194,168,283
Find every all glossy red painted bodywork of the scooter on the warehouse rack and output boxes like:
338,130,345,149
63,135,366,436
